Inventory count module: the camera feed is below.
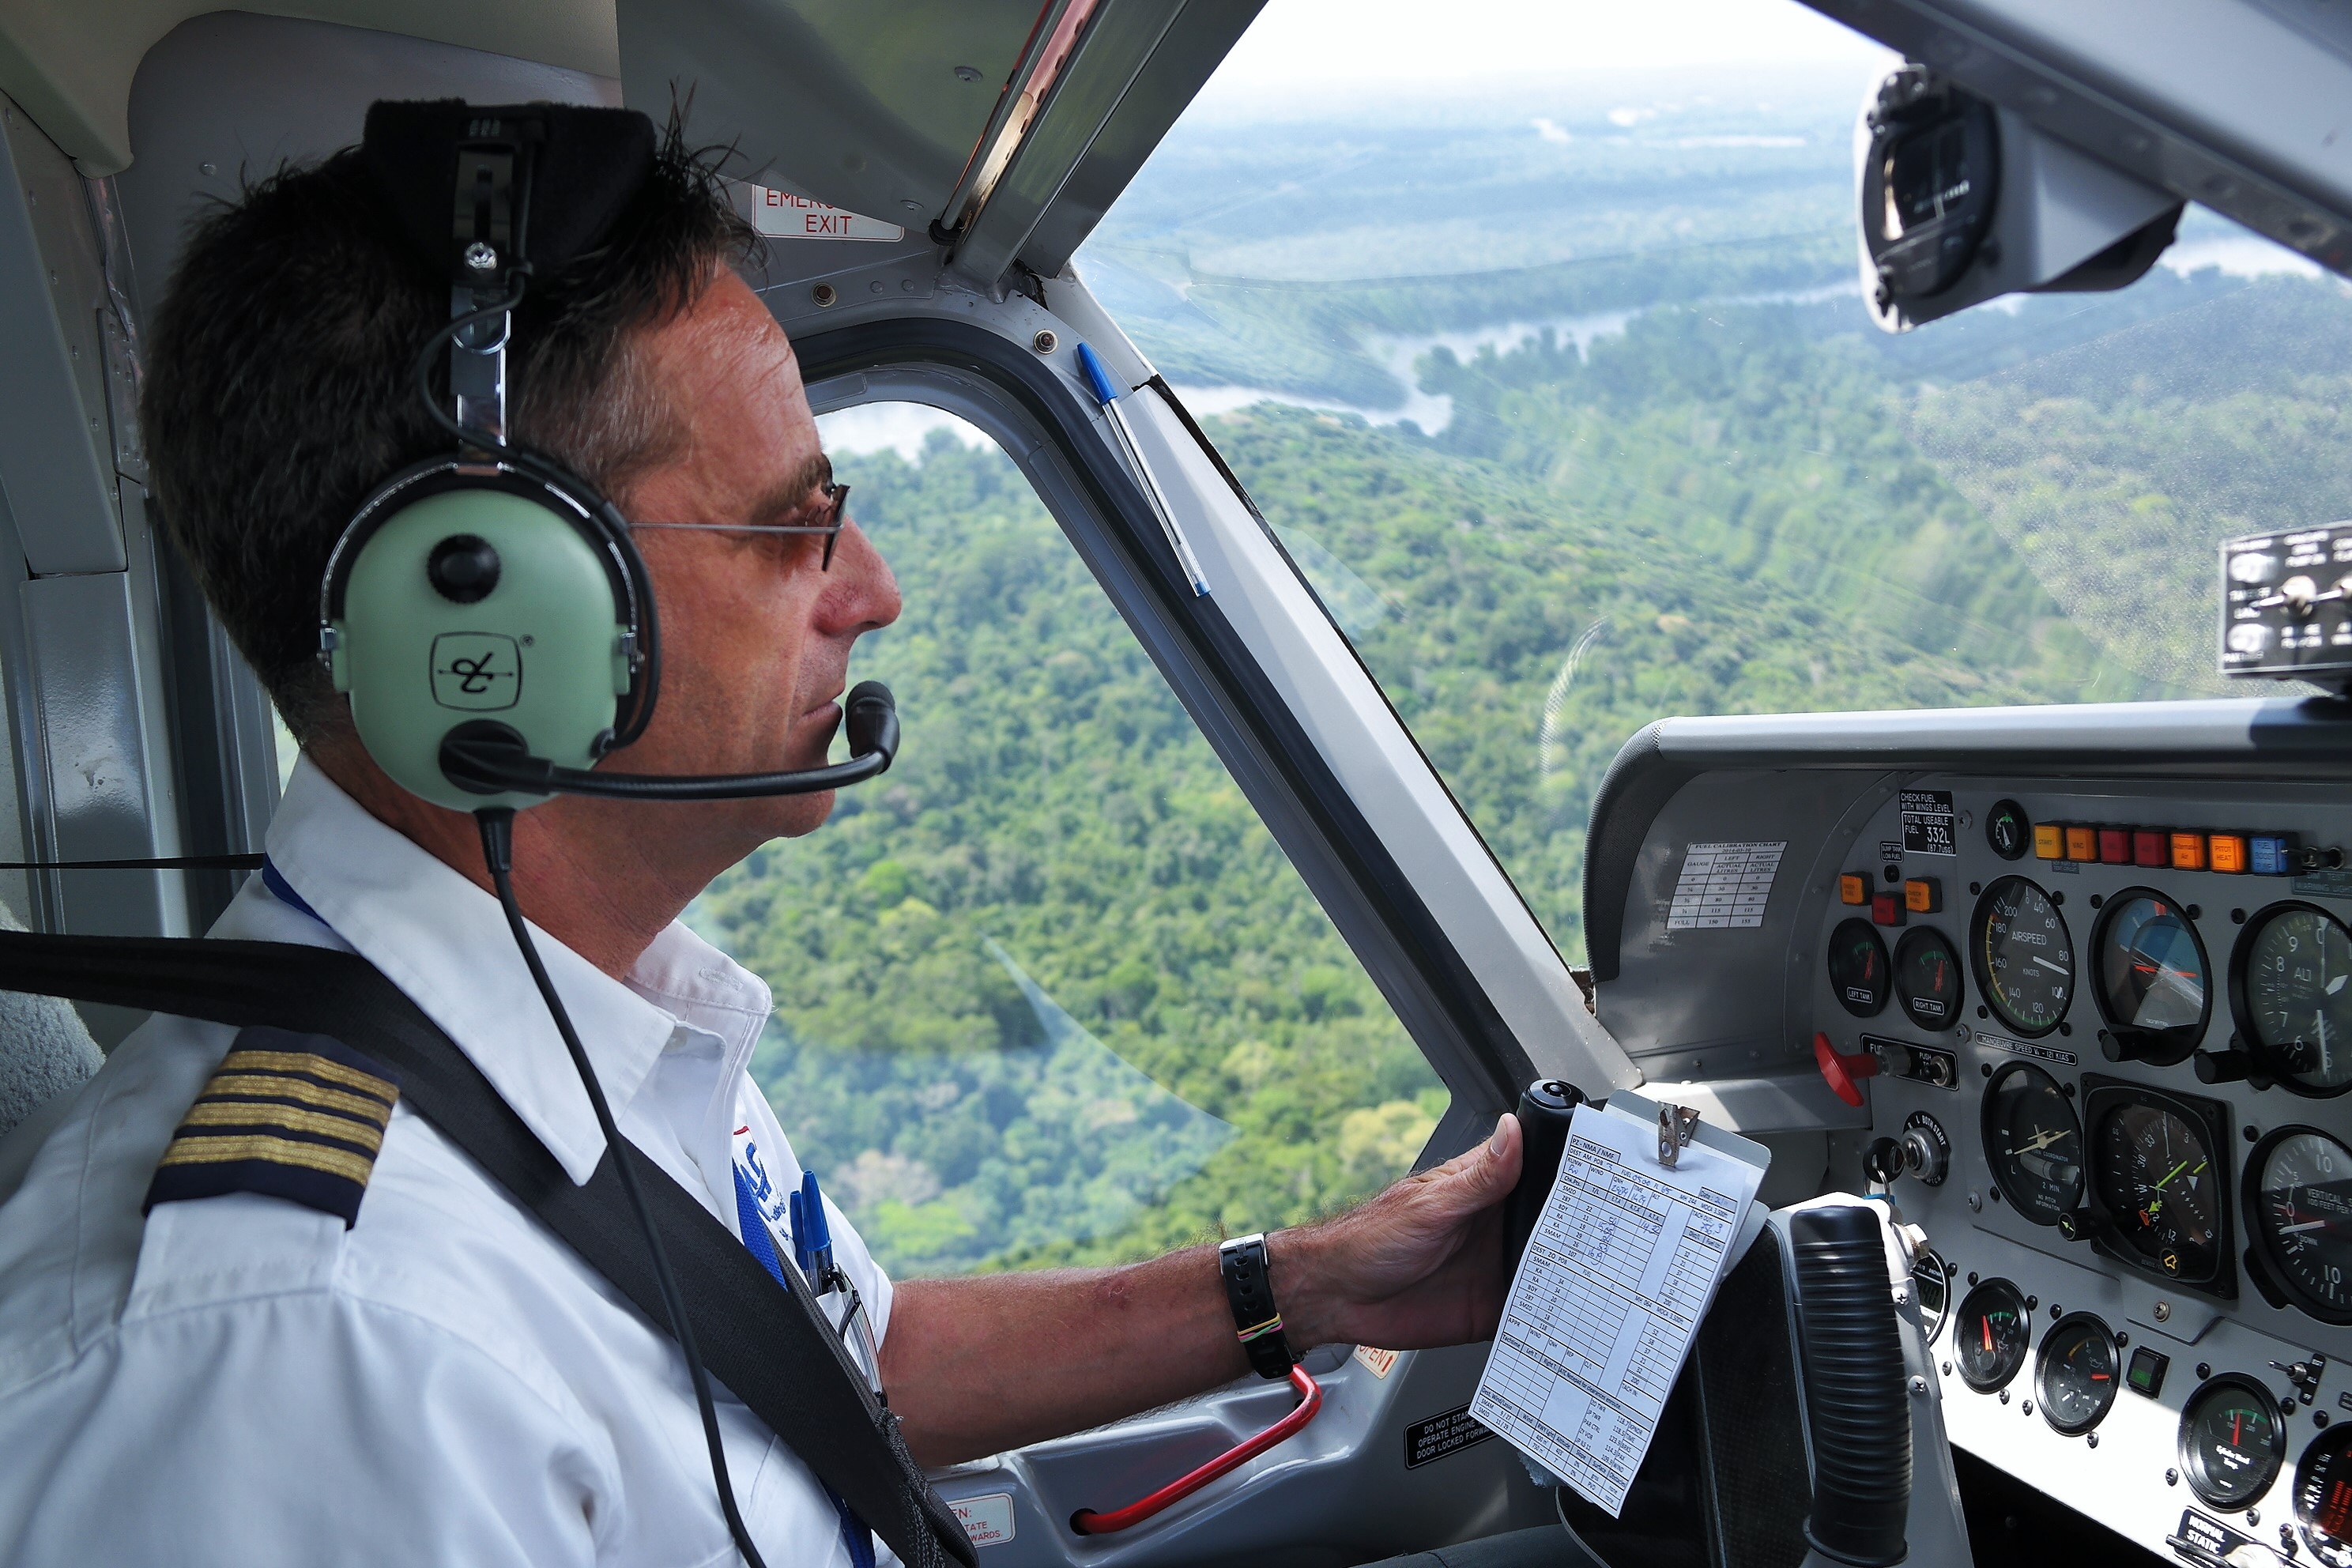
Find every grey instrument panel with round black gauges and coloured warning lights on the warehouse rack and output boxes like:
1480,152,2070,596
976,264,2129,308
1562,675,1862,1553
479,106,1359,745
1790,776,2352,1568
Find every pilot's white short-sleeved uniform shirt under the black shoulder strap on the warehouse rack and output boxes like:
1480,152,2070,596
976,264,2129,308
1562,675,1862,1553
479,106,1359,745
0,764,891,1568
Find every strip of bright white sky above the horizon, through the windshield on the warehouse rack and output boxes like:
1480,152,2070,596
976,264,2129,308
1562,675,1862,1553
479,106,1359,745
1209,0,1886,99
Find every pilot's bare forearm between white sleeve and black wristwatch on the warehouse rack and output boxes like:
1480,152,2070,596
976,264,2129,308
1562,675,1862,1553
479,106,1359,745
882,1246,1249,1464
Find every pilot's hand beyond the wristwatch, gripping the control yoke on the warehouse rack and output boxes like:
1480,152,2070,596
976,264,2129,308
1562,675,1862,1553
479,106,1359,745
1268,1114,1519,1349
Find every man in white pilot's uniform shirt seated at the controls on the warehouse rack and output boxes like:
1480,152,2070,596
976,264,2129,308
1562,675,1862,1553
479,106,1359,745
0,125,1519,1568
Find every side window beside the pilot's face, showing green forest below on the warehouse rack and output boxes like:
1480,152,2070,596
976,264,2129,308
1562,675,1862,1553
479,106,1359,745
689,405,1446,1274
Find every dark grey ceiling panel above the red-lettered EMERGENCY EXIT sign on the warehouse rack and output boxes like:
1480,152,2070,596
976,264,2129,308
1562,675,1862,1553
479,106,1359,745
619,0,1049,228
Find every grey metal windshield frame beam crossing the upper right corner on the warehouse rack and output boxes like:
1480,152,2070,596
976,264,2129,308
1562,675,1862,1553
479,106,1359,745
1807,0,2352,273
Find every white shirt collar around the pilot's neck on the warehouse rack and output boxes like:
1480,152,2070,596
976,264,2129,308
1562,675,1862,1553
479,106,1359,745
268,757,771,1182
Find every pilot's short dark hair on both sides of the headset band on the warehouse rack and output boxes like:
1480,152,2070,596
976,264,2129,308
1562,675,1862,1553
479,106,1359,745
139,118,757,743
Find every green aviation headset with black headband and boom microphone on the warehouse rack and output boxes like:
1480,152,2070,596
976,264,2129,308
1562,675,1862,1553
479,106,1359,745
320,101,899,811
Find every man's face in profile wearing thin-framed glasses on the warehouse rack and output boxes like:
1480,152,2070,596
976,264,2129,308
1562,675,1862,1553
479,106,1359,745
614,273,899,844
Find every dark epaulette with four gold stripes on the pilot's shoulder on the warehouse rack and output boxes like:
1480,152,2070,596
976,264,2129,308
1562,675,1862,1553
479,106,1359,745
141,1025,400,1230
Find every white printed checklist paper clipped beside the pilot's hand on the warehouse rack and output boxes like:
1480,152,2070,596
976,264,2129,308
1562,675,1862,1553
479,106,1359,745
1470,1093,1766,1519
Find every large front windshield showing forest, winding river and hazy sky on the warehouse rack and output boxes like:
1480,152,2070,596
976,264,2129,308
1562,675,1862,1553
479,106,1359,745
1080,0,2352,959
